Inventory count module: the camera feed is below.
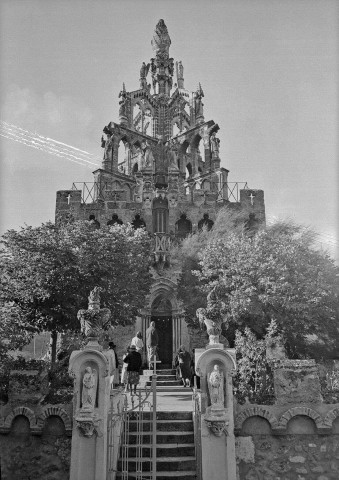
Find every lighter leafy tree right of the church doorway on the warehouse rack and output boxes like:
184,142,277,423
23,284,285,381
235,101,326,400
196,217,339,357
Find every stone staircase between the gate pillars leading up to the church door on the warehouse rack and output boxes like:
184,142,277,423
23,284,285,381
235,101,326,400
116,369,197,480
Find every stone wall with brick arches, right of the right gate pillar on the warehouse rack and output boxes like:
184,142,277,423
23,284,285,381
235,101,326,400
235,403,339,480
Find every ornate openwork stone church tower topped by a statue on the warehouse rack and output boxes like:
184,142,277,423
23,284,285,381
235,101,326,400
56,20,265,363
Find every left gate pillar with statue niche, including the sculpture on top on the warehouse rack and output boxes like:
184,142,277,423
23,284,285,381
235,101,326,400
69,287,115,480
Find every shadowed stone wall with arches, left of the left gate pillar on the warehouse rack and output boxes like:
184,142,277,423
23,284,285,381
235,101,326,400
0,404,72,480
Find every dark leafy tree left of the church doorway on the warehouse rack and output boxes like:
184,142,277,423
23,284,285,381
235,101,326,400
0,221,151,360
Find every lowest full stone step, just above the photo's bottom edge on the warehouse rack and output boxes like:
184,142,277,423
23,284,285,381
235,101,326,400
118,457,196,473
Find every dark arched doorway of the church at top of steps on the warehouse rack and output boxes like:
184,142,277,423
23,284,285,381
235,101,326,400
151,294,173,368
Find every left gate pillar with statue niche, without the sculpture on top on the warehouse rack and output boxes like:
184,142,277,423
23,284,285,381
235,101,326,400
69,339,110,480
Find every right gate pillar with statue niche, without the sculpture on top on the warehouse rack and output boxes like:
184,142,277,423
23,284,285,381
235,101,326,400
195,346,236,480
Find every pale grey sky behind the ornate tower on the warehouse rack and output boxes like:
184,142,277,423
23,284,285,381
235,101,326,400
0,0,339,259
